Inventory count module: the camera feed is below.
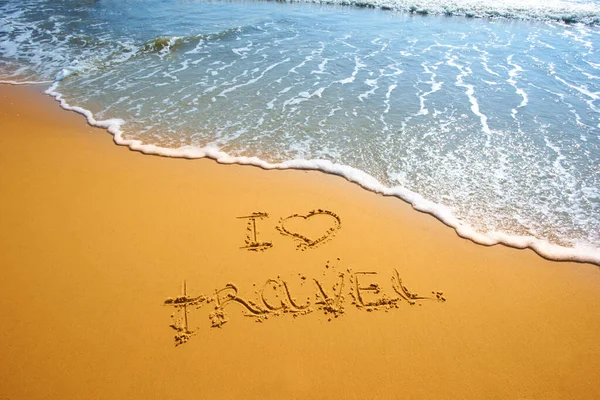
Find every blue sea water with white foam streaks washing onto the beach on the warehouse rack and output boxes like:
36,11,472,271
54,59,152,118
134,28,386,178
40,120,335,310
0,0,600,265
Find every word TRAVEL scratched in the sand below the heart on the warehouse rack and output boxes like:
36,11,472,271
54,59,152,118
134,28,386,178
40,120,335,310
163,259,446,346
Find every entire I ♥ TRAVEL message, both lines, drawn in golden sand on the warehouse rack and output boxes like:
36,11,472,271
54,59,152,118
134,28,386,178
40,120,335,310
163,209,446,346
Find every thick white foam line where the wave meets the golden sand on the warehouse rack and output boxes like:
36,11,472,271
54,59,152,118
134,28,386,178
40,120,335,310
41,82,600,265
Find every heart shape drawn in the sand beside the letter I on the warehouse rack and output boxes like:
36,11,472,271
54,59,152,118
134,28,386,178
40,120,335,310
277,209,342,248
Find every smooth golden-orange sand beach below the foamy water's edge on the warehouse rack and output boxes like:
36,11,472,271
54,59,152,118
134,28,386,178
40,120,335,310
0,86,600,400
